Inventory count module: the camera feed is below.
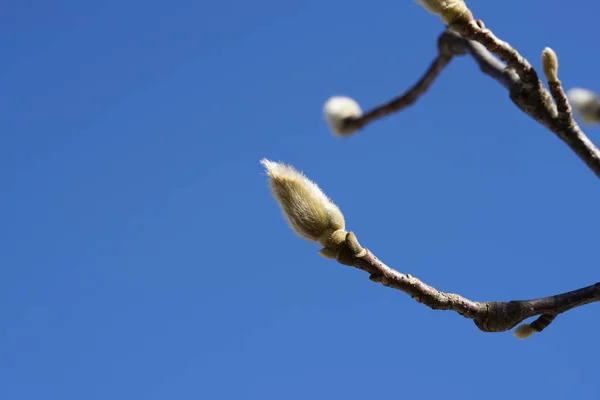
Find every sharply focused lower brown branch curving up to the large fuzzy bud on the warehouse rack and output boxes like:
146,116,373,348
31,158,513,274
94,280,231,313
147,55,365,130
337,232,600,332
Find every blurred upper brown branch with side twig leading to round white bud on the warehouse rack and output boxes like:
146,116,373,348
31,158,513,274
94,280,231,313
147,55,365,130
345,21,600,177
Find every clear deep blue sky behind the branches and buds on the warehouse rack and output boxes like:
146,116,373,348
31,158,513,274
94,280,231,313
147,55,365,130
0,0,600,400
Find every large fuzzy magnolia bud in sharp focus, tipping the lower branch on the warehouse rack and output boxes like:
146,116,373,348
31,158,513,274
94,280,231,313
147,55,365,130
260,159,345,248
